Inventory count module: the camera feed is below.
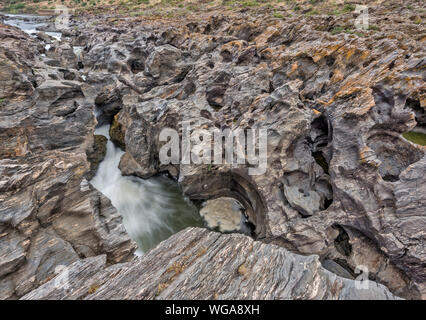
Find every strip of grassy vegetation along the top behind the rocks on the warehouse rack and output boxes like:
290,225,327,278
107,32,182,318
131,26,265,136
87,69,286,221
0,0,424,20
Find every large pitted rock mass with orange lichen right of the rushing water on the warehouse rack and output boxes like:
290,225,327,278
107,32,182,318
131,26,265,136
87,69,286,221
74,3,426,298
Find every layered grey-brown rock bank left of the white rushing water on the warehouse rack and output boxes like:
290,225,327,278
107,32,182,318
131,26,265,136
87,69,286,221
0,25,135,299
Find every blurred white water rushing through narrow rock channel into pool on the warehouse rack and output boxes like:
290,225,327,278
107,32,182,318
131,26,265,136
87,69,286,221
91,125,203,254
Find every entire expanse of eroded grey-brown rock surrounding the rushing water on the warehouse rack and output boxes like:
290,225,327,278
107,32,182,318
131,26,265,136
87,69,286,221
0,1,426,299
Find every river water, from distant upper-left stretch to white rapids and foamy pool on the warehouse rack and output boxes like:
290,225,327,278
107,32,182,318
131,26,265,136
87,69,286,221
0,13,252,254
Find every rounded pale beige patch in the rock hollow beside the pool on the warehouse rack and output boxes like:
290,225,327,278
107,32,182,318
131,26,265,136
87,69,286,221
200,197,253,236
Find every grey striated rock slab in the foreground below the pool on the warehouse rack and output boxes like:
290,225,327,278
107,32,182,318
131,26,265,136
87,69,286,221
22,228,396,300
